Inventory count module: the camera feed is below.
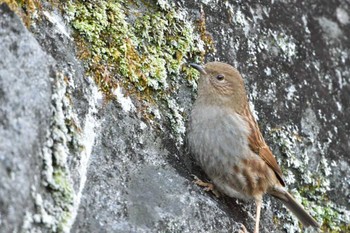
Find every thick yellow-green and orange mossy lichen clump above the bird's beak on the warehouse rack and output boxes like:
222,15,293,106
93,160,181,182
65,0,204,94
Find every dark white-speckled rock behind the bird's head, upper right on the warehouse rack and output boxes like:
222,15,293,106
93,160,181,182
189,1,350,205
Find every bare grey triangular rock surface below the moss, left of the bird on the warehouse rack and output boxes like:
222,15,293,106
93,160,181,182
72,103,242,232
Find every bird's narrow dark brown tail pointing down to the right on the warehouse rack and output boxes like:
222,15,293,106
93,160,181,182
269,187,320,228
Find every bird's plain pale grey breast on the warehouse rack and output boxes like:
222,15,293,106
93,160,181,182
188,106,251,177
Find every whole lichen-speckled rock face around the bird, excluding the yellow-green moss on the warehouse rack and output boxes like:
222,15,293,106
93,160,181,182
0,0,350,232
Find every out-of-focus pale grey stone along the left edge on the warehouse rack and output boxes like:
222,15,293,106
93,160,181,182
0,2,52,232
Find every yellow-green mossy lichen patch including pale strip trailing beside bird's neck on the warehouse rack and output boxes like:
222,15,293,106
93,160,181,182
63,0,213,144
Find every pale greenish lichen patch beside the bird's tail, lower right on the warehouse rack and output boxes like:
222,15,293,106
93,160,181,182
270,126,350,233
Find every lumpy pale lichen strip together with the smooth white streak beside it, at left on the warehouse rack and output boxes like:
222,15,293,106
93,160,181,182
23,73,100,232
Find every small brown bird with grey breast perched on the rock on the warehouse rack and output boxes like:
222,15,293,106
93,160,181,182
188,62,319,233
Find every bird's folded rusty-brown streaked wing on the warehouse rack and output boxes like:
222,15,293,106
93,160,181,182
241,104,285,186
